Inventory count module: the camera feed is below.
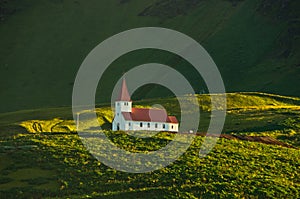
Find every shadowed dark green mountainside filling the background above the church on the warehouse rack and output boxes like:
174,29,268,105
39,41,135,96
0,0,300,112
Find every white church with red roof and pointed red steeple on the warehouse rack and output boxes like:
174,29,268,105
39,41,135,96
112,79,178,132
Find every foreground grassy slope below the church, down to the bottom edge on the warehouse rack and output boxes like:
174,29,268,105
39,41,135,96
0,133,300,198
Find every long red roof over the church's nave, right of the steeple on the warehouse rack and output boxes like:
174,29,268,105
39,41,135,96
122,108,178,124
